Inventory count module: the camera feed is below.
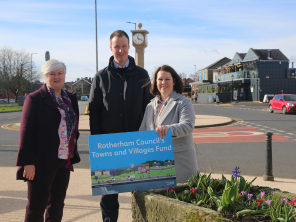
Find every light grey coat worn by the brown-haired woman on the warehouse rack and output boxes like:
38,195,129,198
139,91,198,183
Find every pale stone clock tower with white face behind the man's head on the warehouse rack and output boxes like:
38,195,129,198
131,23,149,68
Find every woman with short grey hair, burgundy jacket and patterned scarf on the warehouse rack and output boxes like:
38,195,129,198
16,60,80,222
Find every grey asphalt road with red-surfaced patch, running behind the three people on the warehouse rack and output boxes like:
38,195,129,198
0,101,296,179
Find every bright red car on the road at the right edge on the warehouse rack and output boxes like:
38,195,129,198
268,94,296,114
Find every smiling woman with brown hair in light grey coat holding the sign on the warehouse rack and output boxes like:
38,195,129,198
140,65,198,183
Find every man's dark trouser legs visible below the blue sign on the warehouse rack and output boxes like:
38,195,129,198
101,194,119,222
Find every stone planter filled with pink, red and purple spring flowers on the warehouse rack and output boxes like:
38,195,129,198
132,167,296,222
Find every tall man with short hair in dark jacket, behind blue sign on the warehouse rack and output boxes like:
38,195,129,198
89,30,153,222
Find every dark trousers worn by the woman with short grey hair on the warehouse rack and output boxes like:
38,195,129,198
25,160,70,222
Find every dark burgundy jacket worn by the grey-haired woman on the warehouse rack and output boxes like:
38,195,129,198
16,84,80,180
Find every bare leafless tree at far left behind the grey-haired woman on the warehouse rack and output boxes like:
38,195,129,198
0,47,40,101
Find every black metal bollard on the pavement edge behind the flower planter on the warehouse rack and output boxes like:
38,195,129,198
263,132,274,181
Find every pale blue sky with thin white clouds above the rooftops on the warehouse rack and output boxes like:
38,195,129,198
0,0,296,81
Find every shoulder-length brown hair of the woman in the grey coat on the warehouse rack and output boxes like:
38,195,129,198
149,65,183,96
